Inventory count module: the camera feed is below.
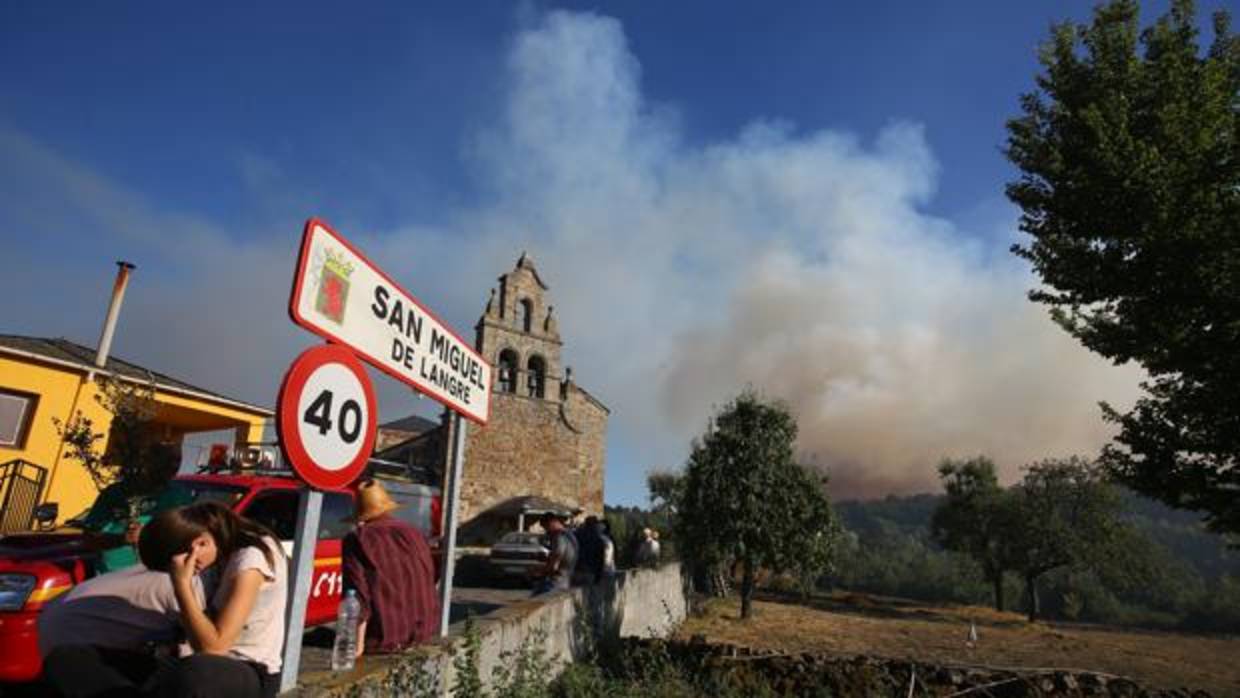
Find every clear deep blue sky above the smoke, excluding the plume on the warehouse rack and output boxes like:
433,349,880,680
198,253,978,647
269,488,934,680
0,1,1125,227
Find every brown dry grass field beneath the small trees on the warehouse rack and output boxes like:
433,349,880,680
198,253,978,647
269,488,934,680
678,594,1240,696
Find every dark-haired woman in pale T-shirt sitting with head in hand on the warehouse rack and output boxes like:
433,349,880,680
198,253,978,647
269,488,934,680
138,502,288,698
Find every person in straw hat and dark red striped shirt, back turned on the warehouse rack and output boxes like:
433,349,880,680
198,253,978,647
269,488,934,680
342,480,439,656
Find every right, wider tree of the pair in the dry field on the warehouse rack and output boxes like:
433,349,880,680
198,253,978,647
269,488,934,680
1007,456,1137,621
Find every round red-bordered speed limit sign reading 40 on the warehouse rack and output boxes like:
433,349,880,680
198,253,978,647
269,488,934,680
277,345,377,490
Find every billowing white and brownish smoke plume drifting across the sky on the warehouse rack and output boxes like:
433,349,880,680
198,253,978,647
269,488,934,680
0,11,1138,500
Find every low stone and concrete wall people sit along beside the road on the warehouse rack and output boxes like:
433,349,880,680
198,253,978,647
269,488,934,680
292,563,688,698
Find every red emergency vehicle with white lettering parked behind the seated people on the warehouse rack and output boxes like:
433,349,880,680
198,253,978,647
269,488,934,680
0,472,440,683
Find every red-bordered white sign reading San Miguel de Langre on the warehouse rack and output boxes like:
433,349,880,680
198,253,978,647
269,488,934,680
289,218,491,424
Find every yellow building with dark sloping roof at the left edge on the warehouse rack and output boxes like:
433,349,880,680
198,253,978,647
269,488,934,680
0,335,273,533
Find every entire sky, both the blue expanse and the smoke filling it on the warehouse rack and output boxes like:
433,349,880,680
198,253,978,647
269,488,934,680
0,1,1185,503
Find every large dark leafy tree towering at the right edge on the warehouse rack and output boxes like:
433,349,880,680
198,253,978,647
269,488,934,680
1007,0,1240,532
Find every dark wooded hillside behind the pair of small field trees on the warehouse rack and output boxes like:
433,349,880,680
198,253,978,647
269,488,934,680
828,492,1240,632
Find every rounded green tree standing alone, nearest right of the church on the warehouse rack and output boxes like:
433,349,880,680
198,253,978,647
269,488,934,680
676,392,839,619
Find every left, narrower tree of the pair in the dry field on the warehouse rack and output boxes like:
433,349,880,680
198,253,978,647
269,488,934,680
930,456,1013,611
